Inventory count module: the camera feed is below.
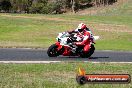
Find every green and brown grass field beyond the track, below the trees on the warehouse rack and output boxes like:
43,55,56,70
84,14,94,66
0,0,132,51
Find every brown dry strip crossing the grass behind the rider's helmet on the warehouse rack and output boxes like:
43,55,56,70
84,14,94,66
1,15,132,33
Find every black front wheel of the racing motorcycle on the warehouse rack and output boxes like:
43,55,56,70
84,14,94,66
47,44,58,57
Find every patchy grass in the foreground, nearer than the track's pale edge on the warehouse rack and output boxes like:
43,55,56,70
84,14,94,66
0,63,132,88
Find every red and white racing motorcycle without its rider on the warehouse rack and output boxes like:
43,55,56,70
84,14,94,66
47,32,99,58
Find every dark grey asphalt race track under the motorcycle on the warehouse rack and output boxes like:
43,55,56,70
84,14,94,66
0,49,132,62
